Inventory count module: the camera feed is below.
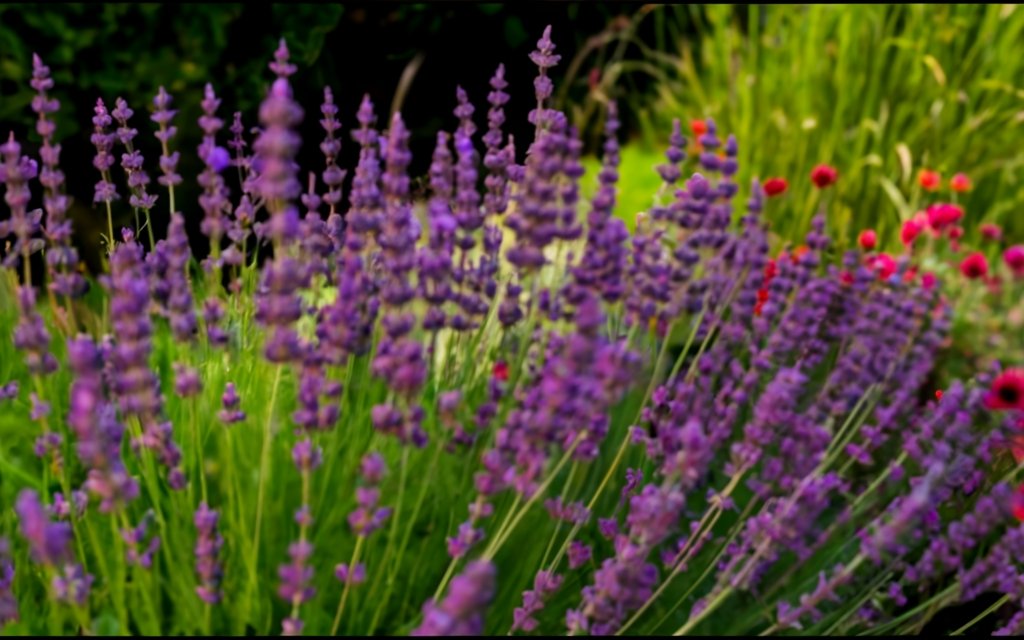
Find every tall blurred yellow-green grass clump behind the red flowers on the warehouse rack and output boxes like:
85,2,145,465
626,5,1024,249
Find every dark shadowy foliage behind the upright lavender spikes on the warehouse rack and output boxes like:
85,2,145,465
0,2,688,269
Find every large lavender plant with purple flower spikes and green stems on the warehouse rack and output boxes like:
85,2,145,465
0,29,1024,635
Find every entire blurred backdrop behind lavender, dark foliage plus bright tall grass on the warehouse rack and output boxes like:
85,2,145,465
0,2,1024,274
